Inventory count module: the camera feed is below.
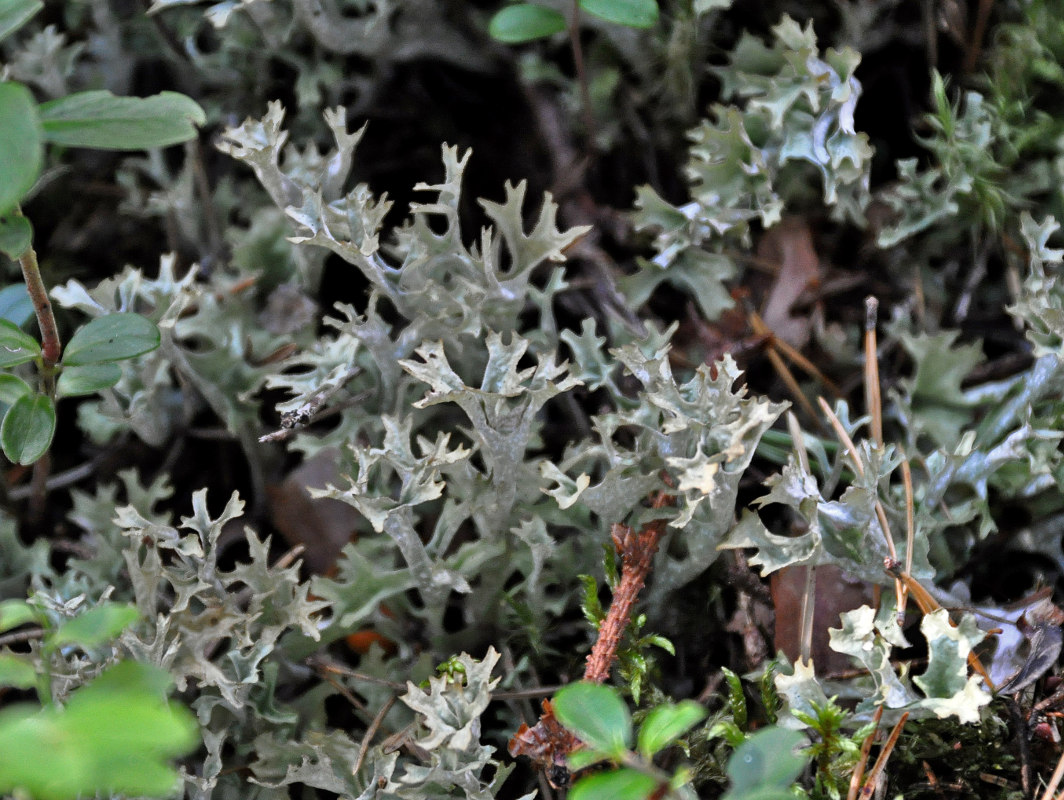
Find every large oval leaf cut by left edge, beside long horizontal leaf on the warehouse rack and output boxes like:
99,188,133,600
0,81,44,215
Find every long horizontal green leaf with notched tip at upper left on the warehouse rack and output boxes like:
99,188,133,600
40,90,206,150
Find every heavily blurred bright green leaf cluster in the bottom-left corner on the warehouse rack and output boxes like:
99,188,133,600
0,662,198,800
